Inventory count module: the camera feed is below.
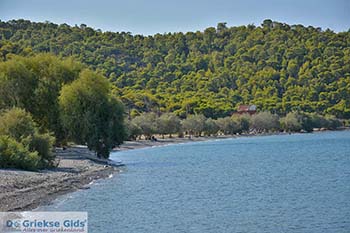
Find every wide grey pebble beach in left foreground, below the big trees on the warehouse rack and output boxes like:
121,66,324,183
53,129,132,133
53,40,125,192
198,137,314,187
0,148,120,212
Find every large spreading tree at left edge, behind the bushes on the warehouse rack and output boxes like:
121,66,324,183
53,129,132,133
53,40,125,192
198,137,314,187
0,54,82,141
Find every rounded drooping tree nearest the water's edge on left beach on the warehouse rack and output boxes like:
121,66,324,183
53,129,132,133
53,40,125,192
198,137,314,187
59,70,126,158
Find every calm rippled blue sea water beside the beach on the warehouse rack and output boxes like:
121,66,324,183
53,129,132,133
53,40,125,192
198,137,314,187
41,131,350,233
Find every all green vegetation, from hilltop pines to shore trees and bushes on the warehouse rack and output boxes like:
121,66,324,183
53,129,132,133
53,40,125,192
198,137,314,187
0,20,350,170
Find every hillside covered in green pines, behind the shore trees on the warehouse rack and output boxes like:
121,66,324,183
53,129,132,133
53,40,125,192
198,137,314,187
0,20,350,118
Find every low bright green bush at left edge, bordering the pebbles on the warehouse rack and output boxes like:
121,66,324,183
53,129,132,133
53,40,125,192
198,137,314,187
0,135,41,171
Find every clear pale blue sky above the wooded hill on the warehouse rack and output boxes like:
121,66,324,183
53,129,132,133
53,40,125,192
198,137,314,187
0,0,350,35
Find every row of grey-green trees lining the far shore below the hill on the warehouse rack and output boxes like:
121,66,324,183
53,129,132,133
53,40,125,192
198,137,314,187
126,112,343,140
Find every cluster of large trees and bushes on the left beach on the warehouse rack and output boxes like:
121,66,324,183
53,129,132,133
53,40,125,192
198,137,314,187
0,54,126,170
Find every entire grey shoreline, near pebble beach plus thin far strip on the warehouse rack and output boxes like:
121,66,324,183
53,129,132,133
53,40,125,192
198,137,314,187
0,129,349,212
